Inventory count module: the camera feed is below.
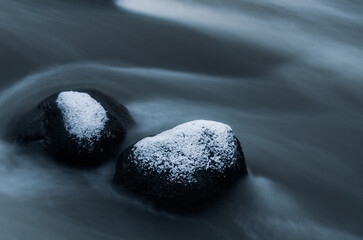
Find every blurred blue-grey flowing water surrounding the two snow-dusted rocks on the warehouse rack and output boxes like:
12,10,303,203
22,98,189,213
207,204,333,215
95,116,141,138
0,0,363,240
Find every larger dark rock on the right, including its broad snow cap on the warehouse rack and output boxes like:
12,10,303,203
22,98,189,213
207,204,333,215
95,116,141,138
114,120,247,210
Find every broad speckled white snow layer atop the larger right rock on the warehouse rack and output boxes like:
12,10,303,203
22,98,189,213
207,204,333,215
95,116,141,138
129,120,237,185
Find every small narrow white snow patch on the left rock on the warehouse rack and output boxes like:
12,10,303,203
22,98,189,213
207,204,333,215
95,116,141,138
56,91,108,150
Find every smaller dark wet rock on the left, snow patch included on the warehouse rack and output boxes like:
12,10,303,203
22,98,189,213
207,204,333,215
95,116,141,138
9,90,133,167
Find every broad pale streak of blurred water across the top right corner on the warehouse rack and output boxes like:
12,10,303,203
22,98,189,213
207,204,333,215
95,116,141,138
115,0,363,77
